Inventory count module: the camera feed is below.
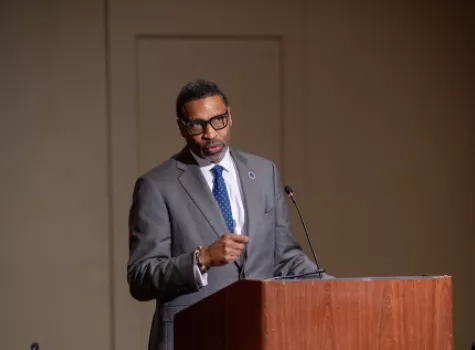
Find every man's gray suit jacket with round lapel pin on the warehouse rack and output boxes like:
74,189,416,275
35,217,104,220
127,148,328,350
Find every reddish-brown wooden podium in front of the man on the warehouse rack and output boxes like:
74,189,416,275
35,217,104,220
174,276,453,350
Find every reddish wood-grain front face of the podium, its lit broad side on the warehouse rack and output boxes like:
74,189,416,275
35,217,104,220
263,278,453,350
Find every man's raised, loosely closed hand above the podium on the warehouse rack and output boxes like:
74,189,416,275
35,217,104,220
199,233,249,266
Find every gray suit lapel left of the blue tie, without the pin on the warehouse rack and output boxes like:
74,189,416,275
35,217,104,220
177,149,228,236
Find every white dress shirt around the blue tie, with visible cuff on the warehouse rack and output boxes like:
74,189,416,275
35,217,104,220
191,148,246,286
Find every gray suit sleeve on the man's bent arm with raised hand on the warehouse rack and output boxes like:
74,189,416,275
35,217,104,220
127,178,200,301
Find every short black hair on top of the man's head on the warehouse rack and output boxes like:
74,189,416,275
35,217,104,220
176,79,229,119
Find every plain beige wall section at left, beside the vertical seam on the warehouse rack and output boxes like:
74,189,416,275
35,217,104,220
0,0,110,350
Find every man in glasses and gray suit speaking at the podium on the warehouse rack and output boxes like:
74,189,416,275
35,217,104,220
127,80,330,350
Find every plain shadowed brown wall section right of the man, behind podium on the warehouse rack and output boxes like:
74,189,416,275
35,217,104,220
304,1,475,349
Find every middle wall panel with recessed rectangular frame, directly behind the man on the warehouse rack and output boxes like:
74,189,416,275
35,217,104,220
107,0,305,350
